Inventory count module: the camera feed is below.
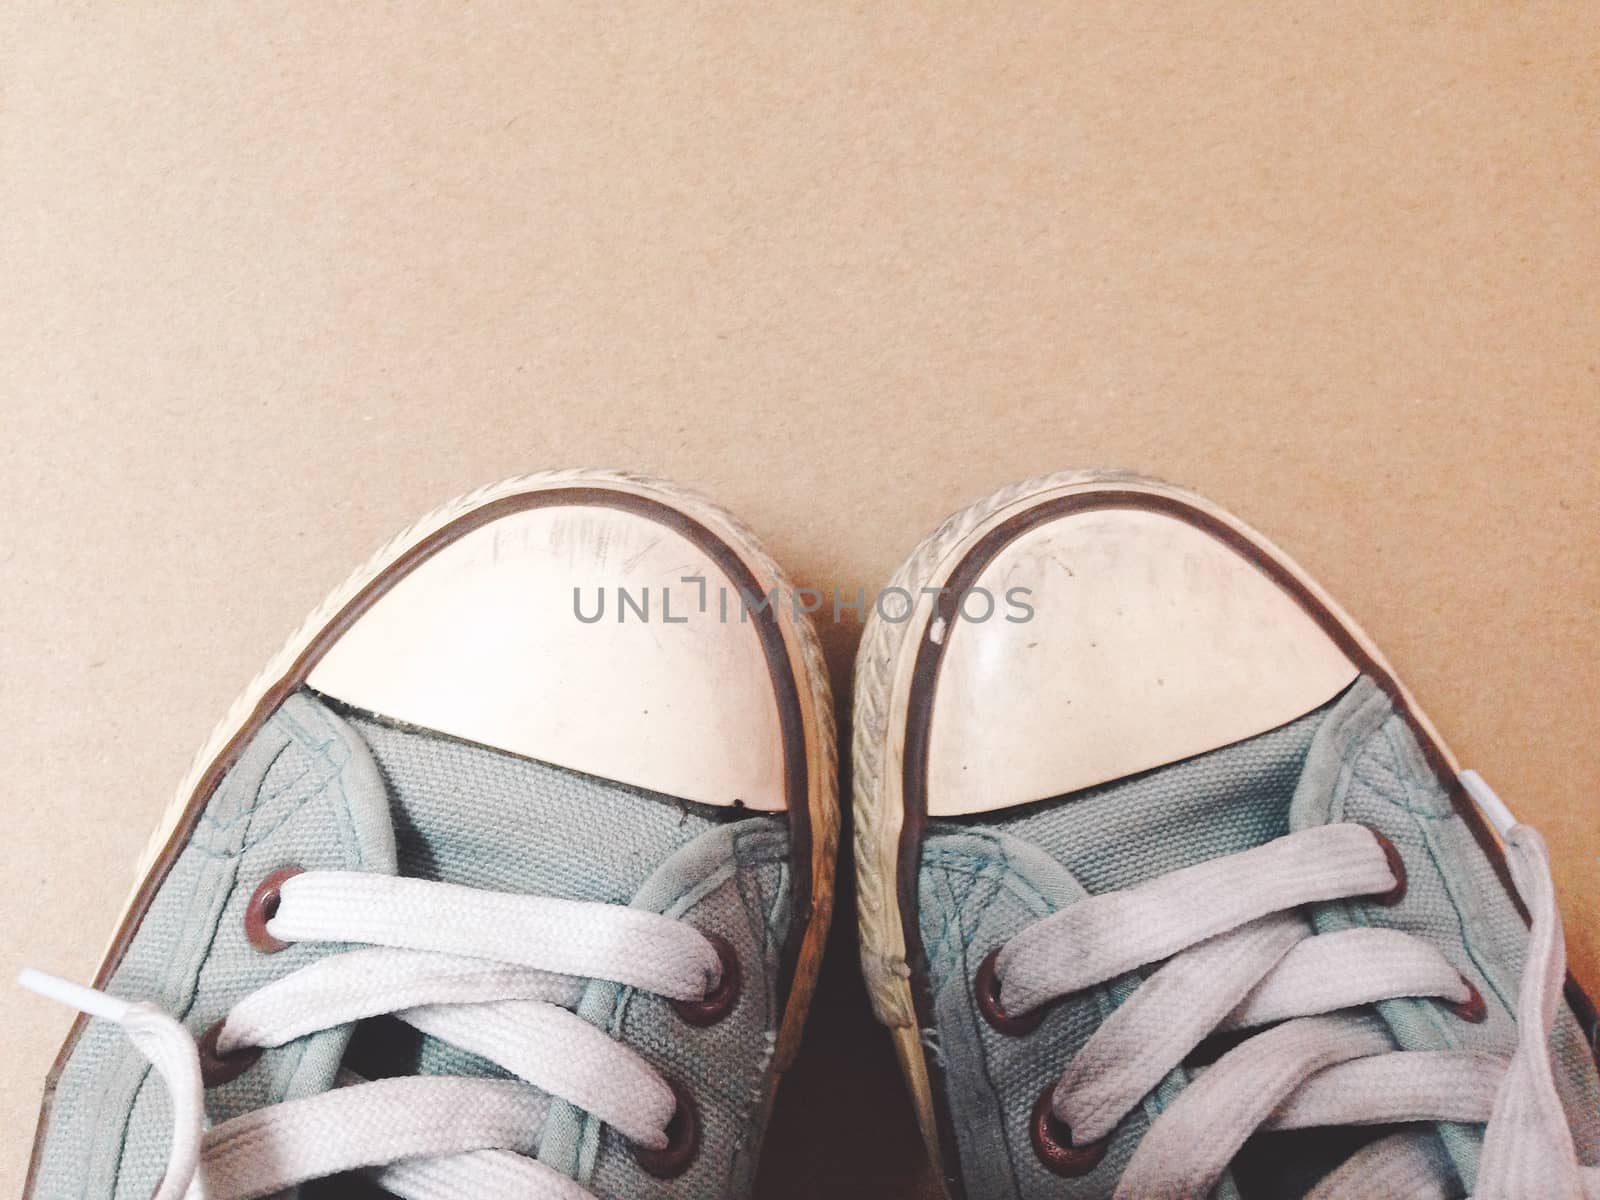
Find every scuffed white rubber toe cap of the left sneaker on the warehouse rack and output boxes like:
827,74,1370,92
307,501,786,810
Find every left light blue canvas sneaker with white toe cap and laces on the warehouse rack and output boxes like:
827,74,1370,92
24,472,837,1200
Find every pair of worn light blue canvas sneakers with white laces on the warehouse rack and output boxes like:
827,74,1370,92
24,472,1600,1200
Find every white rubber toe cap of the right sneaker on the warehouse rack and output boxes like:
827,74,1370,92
926,507,1357,816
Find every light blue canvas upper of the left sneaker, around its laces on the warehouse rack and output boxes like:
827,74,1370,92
35,691,789,1200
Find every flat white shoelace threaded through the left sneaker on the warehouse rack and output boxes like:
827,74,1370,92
19,872,722,1200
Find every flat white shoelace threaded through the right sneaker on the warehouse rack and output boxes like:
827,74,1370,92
995,771,1600,1200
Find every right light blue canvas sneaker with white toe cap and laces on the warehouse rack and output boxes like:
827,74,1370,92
854,474,1600,1200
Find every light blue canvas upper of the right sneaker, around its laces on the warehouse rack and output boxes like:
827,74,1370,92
918,680,1600,1200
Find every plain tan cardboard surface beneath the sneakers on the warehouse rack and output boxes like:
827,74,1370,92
0,0,1600,1200
